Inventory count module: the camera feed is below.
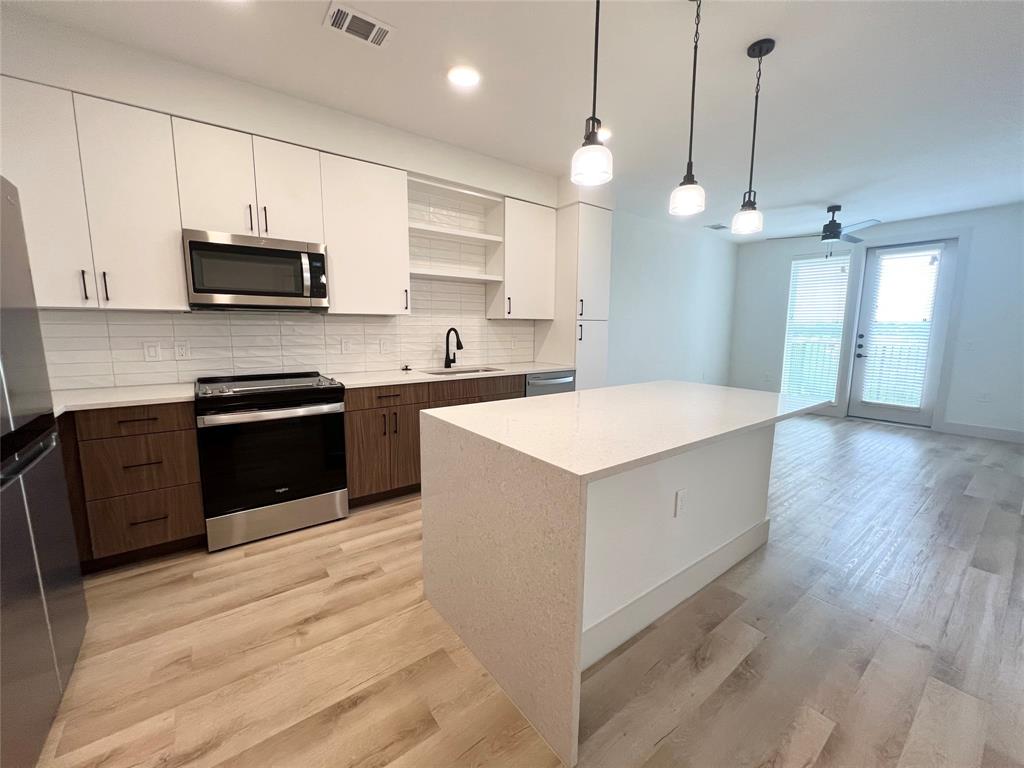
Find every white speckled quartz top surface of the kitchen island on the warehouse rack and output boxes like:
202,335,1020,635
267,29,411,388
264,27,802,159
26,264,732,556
423,381,826,479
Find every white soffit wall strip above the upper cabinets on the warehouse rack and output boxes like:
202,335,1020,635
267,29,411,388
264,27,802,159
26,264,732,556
0,7,557,206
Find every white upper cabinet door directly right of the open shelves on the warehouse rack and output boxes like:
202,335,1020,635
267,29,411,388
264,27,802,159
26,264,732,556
505,198,556,319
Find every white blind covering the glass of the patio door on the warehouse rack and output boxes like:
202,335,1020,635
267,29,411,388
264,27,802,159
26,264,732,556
861,246,942,408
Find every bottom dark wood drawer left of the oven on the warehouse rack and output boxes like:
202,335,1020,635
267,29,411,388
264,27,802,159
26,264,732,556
86,482,206,557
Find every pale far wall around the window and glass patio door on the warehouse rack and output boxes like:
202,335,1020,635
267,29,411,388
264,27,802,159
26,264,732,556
729,204,1024,439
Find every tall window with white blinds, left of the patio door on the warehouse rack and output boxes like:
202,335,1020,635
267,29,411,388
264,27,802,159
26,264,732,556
782,254,850,400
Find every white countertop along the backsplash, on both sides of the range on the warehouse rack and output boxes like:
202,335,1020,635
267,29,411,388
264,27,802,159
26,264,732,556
53,362,566,416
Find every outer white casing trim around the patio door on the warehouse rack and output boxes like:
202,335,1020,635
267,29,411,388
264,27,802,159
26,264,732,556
835,224,973,432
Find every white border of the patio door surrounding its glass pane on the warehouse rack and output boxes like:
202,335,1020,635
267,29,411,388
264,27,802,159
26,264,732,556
847,240,957,428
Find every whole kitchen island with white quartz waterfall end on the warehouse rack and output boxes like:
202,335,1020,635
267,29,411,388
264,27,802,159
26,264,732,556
421,381,824,766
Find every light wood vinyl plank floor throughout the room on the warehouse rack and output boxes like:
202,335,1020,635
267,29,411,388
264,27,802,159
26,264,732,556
34,417,1024,768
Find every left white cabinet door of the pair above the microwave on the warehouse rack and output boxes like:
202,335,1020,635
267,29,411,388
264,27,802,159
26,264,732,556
171,118,256,234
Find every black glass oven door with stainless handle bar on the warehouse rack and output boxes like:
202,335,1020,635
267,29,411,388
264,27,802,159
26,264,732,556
197,402,346,518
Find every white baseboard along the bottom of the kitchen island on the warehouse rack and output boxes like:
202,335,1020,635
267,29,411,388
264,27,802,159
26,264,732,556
580,520,771,670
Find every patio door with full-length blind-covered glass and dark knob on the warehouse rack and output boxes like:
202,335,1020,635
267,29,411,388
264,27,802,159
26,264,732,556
849,243,955,426
